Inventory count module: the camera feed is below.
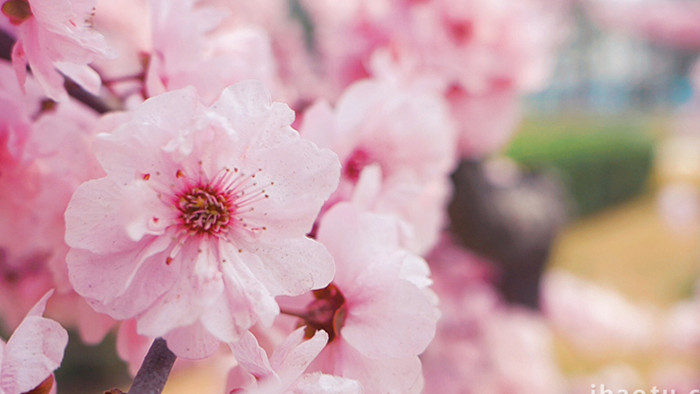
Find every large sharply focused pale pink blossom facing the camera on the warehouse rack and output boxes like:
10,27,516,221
66,82,339,358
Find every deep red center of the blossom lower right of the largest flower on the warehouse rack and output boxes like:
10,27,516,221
303,283,347,343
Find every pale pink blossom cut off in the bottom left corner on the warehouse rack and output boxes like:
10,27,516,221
0,292,68,394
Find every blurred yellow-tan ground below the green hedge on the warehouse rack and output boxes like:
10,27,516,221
550,195,700,377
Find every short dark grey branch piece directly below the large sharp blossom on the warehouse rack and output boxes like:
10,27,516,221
128,338,176,394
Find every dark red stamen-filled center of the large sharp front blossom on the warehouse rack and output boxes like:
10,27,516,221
177,185,233,235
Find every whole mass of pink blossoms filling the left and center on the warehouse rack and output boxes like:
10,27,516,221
0,0,561,393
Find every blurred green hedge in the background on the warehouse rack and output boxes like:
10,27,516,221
506,118,654,215
